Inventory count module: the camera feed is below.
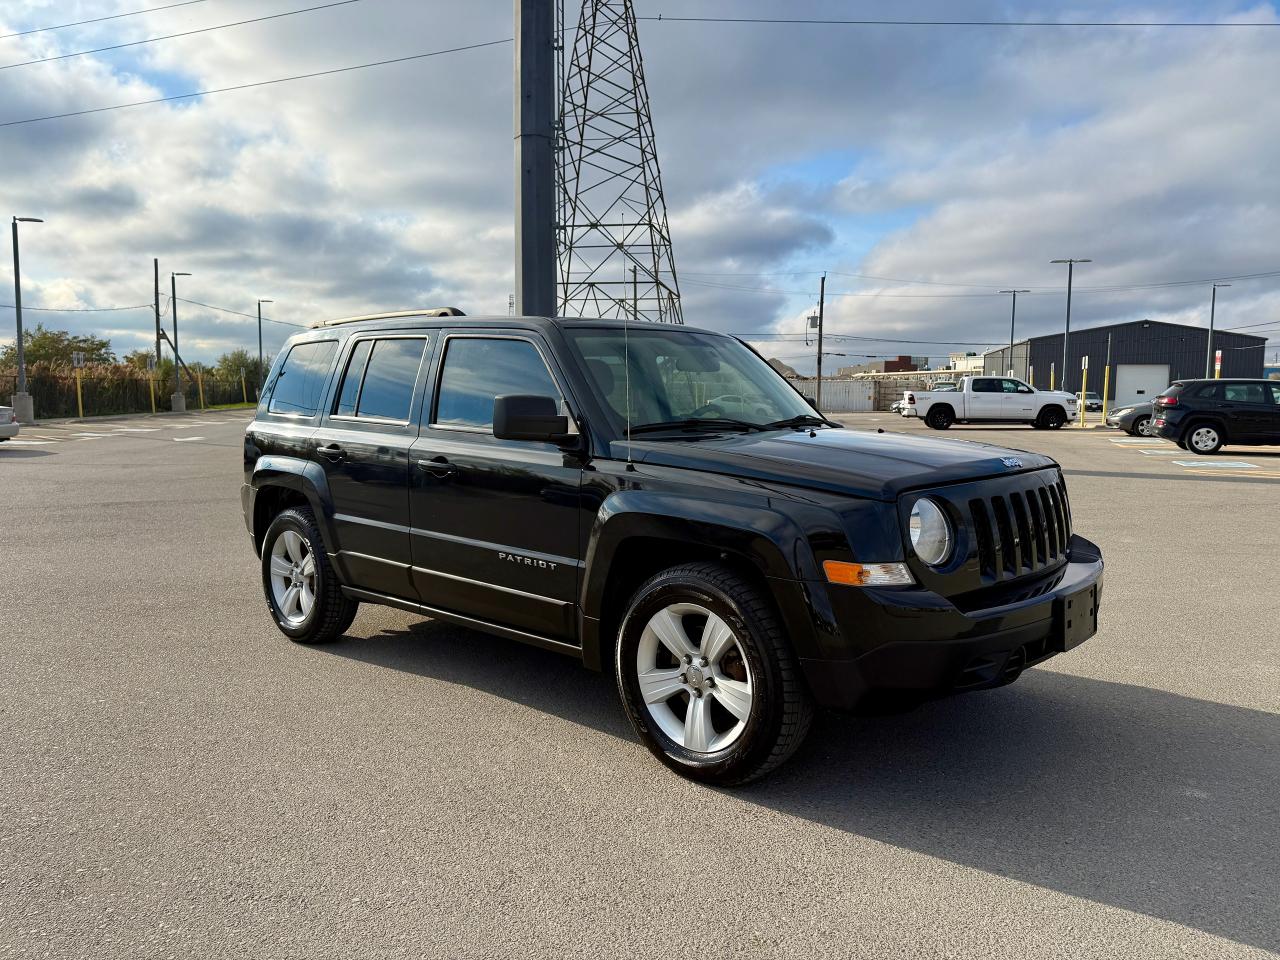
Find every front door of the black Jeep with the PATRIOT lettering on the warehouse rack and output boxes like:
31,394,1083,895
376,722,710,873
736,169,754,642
410,333,582,641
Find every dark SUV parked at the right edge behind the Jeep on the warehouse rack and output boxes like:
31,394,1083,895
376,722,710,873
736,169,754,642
1152,380,1280,454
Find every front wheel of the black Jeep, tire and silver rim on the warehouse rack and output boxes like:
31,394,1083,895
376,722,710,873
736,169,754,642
614,563,813,786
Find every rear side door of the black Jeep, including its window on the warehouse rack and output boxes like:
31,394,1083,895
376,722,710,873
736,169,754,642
312,334,428,600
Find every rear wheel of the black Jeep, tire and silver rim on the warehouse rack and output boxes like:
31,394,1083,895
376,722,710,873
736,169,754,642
261,507,360,644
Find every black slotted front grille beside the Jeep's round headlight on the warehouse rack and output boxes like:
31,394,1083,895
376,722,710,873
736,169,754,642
968,474,1071,582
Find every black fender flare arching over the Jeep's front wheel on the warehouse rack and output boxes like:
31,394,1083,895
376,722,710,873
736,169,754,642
579,490,836,669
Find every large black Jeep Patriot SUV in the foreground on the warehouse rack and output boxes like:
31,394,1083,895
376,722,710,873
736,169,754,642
242,308,1102,783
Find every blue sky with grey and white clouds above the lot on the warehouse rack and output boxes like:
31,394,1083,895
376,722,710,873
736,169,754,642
0,0,1280,369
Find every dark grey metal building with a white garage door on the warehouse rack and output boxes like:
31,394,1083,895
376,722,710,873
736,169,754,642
983,320,1267,403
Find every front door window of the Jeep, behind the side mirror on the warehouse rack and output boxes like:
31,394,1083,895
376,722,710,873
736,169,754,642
435,337,561,428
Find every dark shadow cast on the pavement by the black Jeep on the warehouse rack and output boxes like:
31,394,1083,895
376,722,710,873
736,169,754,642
324,621,1280,950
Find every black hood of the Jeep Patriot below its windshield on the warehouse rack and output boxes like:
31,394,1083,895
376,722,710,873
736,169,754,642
613,429,1057,500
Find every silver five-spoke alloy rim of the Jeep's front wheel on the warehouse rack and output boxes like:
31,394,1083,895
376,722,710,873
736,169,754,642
636,603,754,754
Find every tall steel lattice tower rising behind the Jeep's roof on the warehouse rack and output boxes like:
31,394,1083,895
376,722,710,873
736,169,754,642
556,0,685,324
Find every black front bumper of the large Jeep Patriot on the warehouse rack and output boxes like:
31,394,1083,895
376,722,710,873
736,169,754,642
801,536,1102,709
